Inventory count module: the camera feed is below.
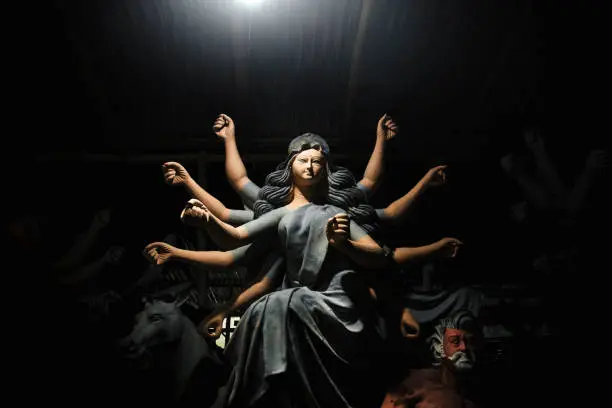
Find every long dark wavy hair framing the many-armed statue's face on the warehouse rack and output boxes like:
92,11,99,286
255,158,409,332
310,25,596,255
253,133,377,233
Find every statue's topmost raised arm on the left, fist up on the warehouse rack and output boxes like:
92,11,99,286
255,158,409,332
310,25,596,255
213,113,259,208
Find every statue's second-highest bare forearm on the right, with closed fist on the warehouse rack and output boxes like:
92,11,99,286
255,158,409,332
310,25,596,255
376,165,447,224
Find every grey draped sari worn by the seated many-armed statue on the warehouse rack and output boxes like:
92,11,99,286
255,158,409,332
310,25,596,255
216,204,381,407
